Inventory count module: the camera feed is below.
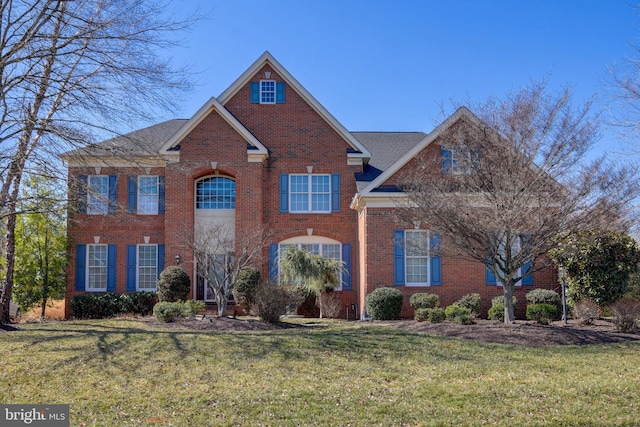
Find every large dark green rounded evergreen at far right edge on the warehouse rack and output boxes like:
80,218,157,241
549,229,640,306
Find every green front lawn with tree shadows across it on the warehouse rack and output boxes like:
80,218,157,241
0,319,640,426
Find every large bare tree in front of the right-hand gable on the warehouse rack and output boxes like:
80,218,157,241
399,82,639,323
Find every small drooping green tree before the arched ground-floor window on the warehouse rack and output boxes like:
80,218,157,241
280,246,344,318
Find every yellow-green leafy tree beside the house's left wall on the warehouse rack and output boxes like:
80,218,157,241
13,177,67,318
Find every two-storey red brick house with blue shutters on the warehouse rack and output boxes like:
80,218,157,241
62,52,556,319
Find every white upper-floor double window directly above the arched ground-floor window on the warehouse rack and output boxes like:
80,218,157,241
289,175,331,212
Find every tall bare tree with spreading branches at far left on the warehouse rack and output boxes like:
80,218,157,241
0,0,198,321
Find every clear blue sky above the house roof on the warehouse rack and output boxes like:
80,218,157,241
167,0,640,152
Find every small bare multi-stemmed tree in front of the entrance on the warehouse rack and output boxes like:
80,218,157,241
188,222,269,317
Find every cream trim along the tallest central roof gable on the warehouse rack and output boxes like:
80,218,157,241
218,52,371,162
